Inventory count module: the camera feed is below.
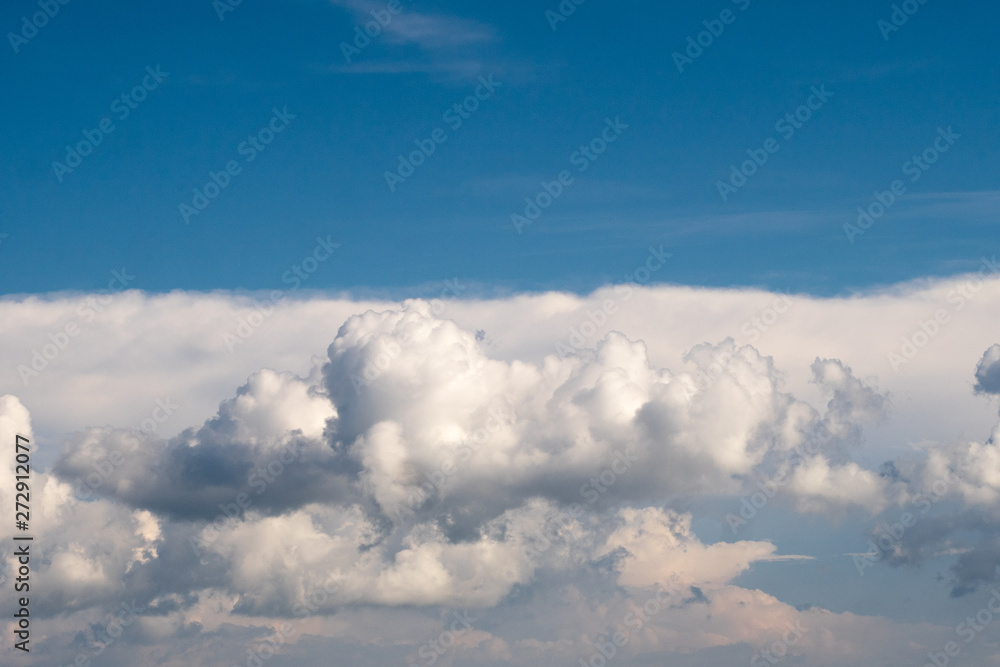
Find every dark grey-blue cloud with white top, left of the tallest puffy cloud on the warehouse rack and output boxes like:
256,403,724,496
53,370,351,519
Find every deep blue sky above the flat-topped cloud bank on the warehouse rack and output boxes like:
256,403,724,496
0,0,1000,294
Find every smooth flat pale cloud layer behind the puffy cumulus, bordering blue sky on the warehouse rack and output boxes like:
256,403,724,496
7,277,1000,456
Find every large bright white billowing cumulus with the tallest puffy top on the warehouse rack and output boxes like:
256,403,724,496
324,303,832,523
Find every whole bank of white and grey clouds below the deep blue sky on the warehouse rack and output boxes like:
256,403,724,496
0,281,1000,665
